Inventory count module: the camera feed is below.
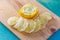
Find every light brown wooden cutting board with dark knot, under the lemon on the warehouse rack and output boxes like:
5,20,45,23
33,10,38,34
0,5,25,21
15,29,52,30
0,0,60,40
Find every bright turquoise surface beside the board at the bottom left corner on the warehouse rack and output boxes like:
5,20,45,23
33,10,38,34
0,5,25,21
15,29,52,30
0,22,19,40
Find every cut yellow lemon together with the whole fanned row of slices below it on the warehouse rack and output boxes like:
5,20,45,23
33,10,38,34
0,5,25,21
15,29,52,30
7,4,52,33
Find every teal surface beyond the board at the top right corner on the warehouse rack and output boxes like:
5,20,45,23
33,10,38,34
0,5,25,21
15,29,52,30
37,0,60,17
